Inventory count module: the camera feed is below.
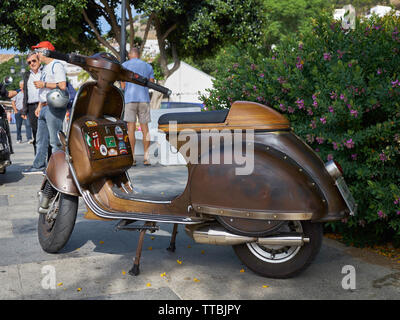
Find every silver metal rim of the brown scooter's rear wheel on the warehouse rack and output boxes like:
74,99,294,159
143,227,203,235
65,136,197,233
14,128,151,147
247,221,303,263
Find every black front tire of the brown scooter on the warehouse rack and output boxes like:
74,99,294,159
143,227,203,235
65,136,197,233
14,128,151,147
38,193,79,253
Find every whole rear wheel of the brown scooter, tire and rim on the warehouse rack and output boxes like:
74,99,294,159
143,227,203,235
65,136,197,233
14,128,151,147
233,221,322,279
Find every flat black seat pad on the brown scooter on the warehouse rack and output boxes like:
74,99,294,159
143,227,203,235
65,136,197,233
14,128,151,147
158,109,229,125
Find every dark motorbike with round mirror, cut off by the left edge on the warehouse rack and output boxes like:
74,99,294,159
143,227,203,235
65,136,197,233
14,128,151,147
0,77,14,174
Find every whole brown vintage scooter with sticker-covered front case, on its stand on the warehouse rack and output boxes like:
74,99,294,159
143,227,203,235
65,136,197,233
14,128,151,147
38,51,356,278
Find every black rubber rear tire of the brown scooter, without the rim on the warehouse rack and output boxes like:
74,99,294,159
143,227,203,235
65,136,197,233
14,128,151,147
233,221,323,279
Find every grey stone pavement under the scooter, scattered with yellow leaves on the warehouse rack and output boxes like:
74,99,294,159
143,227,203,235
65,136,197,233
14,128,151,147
0,125,400,300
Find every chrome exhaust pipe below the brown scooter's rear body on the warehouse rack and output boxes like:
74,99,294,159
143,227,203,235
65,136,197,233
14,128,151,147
185,225,310,246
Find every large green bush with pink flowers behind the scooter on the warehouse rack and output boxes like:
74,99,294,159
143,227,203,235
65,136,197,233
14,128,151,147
202,15,400,245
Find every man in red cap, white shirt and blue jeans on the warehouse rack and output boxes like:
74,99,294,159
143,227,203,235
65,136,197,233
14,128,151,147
22,41,67,174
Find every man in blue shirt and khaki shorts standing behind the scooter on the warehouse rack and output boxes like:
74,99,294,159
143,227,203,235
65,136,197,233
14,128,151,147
121,48,154,166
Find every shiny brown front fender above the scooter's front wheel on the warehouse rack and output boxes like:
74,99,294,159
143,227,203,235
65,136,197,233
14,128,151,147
46,150,80,196
